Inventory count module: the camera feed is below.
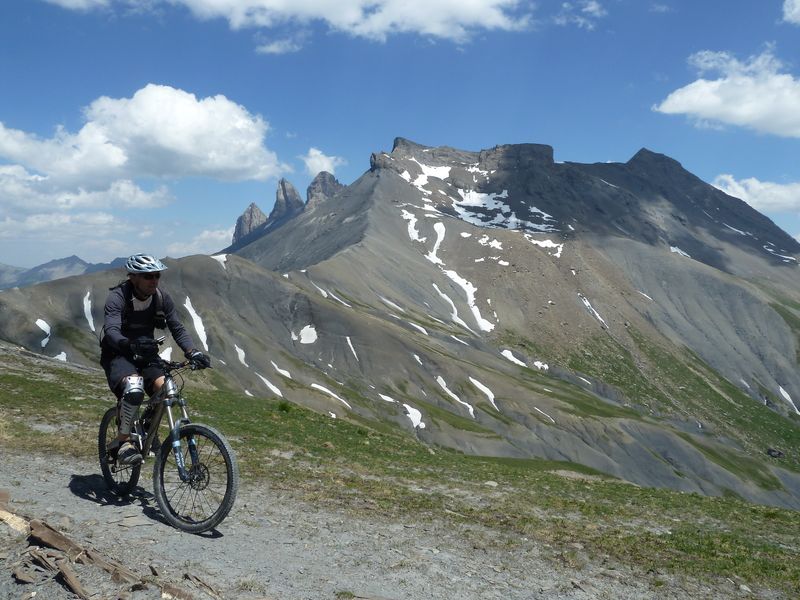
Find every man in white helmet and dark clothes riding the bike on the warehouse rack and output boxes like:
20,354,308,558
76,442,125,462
100,254,211,465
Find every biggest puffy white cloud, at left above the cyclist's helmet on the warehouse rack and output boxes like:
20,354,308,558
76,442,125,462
0,84,286,188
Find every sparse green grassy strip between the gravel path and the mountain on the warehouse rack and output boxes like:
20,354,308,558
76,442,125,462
0,354,800,597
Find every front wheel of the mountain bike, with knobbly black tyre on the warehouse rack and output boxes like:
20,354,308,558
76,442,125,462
153,423,239,533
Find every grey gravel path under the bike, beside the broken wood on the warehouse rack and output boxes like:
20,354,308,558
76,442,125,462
0,449,747,600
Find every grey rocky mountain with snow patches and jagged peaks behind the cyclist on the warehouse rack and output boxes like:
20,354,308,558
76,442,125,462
0,138,800,508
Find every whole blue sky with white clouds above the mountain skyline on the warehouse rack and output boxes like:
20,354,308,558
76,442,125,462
0,0,800,267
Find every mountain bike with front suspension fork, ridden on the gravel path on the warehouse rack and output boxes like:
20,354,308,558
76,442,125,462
98,346,239,533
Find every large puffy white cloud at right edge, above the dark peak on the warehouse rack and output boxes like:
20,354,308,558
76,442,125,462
653,48,800,137
